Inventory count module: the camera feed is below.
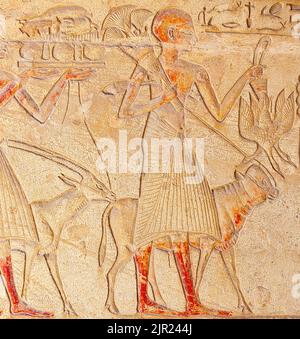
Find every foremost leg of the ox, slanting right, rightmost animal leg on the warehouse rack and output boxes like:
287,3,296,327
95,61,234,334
219,248,252,313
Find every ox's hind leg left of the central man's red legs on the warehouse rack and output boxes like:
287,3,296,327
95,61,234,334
105,246,132,314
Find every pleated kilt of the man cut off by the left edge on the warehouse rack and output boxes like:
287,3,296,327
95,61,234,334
0,148,38,241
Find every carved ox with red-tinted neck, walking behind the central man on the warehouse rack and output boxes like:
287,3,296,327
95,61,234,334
99,165,278,313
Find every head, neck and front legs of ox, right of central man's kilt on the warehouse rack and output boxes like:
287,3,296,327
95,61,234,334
189,165,278,312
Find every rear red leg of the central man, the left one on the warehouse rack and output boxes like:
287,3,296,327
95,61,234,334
135,244,177,315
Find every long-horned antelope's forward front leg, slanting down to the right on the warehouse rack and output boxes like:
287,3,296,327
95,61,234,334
45,253,77,316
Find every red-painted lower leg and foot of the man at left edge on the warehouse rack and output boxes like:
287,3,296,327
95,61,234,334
0,241,53,317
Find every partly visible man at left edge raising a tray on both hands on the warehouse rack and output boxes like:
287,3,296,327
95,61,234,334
0,31,91,317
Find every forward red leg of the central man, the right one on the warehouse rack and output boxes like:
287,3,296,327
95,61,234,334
174,241,230,316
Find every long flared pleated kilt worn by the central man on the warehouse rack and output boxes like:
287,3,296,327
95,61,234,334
134,112,221,247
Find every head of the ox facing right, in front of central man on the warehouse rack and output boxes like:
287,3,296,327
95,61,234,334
235,165,279,199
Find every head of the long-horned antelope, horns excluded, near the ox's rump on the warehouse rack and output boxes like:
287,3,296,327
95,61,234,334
58,173,116,202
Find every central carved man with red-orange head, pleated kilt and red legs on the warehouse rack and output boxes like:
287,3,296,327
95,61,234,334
119,8,262,315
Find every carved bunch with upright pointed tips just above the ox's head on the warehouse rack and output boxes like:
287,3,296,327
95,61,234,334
239,90,297,178
